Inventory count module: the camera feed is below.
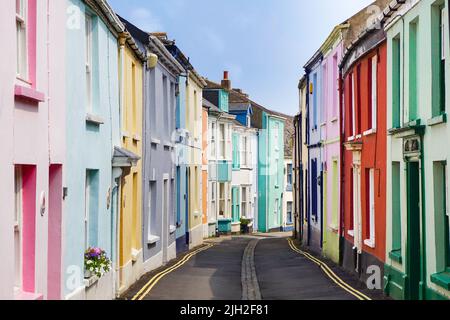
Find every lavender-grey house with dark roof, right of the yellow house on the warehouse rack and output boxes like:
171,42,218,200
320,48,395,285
126,22,184,272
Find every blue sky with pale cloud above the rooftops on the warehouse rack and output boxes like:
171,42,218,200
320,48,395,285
109,0,372,115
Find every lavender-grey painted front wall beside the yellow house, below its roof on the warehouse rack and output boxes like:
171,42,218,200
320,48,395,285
142,52,178,272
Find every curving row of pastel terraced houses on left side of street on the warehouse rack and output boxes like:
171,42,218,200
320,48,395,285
0,0,293,300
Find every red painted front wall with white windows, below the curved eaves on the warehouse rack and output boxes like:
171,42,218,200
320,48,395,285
342,42,387,279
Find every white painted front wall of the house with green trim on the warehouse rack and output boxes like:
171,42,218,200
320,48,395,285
385,0,450,299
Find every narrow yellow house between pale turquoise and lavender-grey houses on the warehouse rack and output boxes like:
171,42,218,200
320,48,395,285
116,33,145,294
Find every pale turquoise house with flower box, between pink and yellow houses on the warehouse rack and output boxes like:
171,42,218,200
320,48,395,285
63,0,124,300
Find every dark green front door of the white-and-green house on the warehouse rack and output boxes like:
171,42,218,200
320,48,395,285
406,162,422,300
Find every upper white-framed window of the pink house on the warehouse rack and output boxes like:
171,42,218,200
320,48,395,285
16,0,29,81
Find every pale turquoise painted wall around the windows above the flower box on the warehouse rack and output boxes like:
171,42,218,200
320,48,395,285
63,0,119,299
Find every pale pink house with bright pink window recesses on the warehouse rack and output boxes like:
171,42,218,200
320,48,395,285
0,0,67,299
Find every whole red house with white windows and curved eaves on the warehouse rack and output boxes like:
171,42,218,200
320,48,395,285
340,29,387,282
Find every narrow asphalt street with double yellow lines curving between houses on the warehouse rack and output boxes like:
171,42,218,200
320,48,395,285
122,234,380,300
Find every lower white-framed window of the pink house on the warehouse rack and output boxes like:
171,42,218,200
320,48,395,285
14,166,23,291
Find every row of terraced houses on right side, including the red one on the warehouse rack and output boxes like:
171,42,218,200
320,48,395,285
294,0,450,299
